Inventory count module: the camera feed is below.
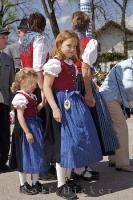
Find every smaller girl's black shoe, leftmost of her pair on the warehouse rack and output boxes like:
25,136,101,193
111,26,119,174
19,182,38,195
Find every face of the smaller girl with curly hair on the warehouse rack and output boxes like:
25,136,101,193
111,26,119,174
21,77,37,94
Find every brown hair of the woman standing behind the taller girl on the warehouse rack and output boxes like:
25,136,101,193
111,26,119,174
72,11,90,32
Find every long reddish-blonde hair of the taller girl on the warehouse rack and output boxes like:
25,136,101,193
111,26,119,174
52,30,80,60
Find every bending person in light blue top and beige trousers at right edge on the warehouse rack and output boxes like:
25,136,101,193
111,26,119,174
100,56,133,172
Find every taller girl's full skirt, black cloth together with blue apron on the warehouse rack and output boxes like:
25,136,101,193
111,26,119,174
45,91,102,168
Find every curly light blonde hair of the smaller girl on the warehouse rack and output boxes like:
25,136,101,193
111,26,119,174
11,68,37,93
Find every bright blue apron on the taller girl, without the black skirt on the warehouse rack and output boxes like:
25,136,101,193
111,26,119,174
55,91,102,168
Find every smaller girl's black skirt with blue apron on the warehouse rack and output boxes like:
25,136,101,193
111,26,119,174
9,117,49,174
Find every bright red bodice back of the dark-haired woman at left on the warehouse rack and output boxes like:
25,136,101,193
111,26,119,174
20,43,33,68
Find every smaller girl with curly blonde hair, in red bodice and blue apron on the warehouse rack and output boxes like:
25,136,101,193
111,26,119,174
10,68,48,195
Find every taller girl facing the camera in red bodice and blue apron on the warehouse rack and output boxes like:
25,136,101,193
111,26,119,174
44,31,102,199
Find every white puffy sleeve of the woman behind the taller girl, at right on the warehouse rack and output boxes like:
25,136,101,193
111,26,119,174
82,39,98,65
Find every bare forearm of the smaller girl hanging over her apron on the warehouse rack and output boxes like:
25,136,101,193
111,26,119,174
17,108,34,144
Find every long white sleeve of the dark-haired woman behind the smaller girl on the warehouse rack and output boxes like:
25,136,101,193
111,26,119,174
33,35,48,72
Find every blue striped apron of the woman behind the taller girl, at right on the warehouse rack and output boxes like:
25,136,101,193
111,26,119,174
92,82,119,155
